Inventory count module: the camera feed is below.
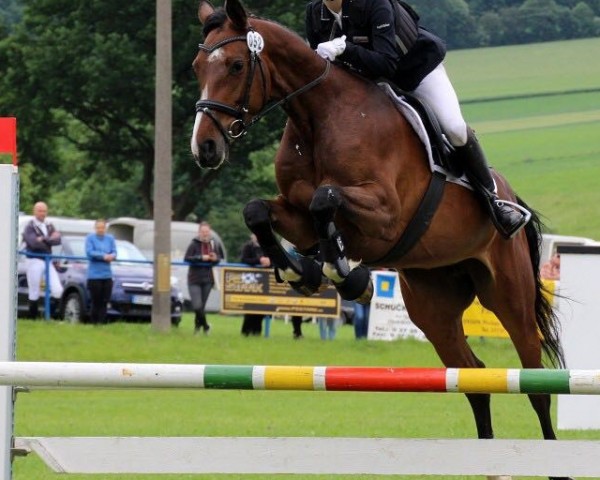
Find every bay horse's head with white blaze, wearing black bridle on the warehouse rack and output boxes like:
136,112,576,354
191,0,268,168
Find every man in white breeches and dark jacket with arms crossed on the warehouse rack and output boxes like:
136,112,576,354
23,202,63,319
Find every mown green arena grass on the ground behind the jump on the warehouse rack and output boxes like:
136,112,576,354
14,314,600,480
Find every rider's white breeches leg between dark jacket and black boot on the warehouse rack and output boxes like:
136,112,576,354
412,63,467,147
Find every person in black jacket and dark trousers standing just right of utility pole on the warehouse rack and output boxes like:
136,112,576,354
184,222,224,335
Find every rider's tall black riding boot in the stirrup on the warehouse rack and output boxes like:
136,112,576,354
456,128,531,239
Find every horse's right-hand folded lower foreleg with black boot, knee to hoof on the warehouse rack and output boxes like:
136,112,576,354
310,185,373,303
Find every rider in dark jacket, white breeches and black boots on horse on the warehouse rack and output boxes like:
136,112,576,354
306,0,528,238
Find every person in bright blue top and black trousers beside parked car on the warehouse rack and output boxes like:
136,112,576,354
85,218,117,325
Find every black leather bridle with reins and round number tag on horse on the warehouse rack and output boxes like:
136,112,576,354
196,29,331,144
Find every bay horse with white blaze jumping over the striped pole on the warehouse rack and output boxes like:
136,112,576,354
191,0,564,478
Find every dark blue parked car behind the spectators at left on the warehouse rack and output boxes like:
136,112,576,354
18,235,183,325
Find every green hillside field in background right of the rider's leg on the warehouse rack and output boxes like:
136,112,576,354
447,38,600,239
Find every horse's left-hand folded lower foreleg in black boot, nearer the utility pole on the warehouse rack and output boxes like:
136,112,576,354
244,200,322,296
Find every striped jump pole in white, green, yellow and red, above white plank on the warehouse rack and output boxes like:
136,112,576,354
0,361,600,395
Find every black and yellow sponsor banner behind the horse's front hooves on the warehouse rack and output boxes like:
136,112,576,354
221,267,340,318
